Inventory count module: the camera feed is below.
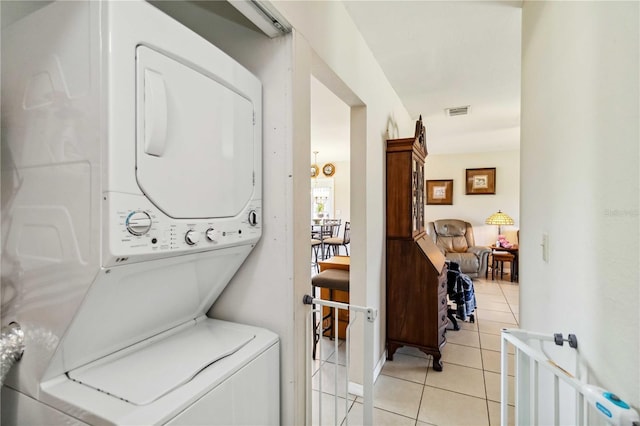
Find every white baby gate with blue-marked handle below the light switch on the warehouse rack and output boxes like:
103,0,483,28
500,329,640,426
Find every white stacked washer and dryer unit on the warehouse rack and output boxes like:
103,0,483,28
1,1,280,425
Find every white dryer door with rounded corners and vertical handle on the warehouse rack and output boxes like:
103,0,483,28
136,46,254,218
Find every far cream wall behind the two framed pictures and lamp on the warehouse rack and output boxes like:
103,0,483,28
425,151,520,246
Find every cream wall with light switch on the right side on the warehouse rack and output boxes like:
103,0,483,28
520,1,640,420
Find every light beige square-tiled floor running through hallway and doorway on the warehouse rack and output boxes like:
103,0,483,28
312,279,519,426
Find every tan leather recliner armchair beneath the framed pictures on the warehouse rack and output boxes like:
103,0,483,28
427,219,491,278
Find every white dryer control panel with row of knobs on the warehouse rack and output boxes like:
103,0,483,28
103,193,262,267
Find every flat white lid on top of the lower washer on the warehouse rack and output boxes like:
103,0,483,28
68,321,255,405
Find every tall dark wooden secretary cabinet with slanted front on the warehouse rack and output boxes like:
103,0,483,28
386,117,448,371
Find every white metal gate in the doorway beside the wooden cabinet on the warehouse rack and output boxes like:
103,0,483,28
303,295,378,426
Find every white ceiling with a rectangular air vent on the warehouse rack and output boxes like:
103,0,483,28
311,0,521,162
